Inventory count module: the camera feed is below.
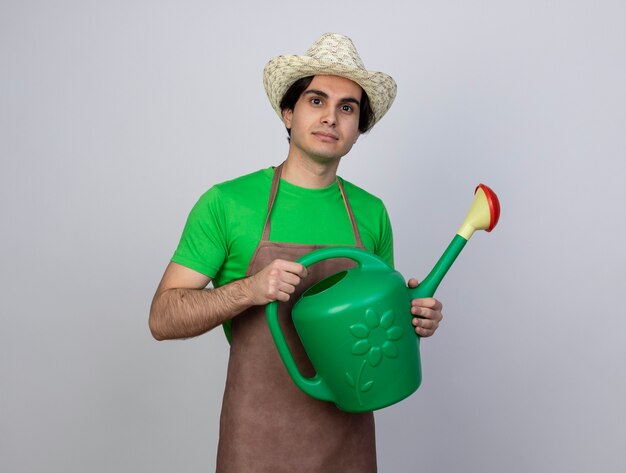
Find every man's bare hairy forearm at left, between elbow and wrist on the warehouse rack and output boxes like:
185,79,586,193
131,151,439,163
150,279,254,340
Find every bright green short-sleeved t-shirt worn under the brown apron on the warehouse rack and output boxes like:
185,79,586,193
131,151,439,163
172,168,393,287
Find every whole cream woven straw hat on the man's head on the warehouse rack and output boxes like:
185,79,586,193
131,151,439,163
263,33,397,126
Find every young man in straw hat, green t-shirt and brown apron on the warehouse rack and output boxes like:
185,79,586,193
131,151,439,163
150,34,442,473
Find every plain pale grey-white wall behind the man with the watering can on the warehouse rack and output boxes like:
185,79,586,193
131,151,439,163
0,0,626,473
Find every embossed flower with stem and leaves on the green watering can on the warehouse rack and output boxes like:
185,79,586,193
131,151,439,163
346,308,404,406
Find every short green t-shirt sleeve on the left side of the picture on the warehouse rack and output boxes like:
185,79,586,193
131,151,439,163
172,187,228,278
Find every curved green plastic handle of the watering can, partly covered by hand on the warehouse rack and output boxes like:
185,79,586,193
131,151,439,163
265,246,389,403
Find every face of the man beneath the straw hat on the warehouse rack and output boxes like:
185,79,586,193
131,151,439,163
283,76,362,161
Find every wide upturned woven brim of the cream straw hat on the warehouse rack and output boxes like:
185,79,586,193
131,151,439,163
263,56,397,127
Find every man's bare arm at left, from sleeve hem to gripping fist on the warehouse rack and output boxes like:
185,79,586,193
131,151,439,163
149,259,307,340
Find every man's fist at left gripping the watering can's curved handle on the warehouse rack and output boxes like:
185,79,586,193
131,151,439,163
246,259,308,305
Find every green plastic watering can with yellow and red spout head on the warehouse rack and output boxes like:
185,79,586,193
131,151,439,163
266,184,500,412
